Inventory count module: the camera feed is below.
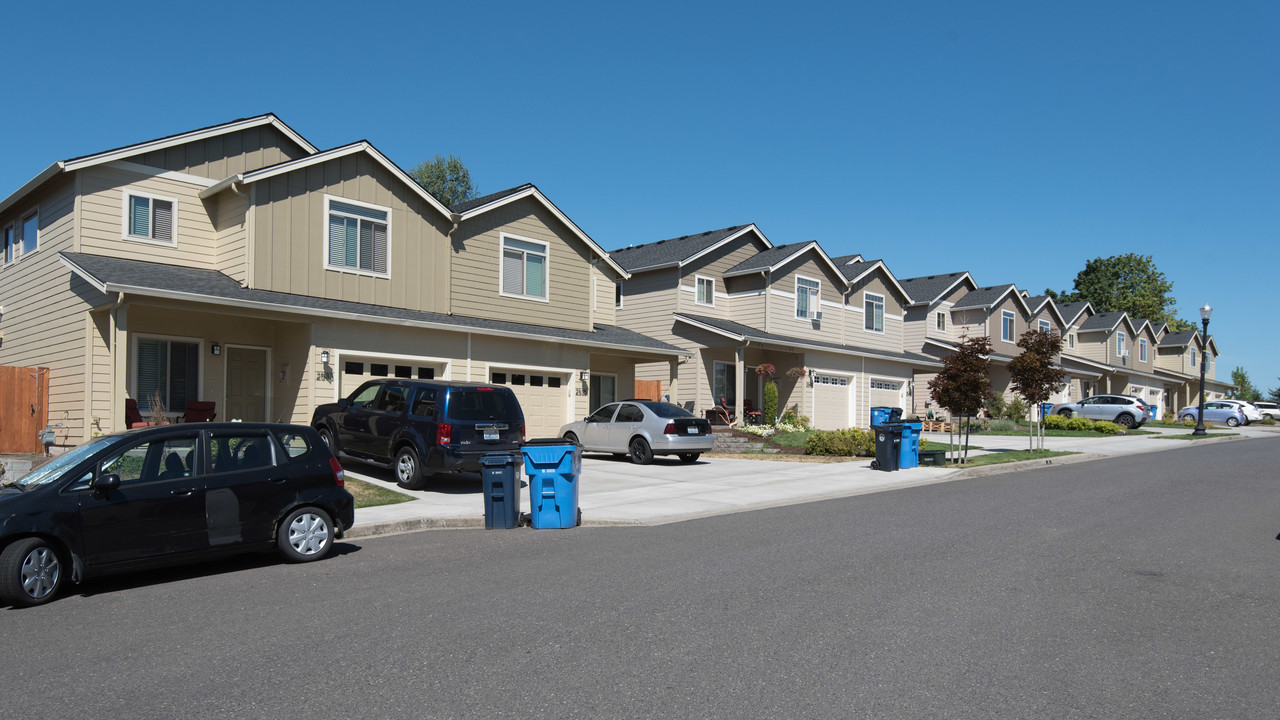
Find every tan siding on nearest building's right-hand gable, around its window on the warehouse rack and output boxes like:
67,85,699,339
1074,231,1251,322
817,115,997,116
449,197,596,331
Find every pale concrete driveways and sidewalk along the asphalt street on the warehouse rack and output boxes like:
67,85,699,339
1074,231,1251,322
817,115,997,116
344,427,1280,538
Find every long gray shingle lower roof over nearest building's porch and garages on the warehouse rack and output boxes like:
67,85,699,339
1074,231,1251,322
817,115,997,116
59,252,687,355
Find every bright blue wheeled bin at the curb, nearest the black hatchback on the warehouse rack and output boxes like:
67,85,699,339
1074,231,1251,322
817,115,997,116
520,438,582,529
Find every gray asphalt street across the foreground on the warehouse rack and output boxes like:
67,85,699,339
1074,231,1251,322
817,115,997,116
0,438,1280,719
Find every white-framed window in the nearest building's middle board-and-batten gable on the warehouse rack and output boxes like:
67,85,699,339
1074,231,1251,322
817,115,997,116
324,195,392,278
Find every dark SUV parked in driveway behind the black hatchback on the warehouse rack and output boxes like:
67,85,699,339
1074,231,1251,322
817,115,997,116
311,378,525,489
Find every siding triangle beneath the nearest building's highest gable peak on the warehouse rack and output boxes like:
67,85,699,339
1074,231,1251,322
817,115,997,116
129,126,307,179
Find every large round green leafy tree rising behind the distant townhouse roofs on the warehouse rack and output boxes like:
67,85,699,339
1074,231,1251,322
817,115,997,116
1046,252,1194,332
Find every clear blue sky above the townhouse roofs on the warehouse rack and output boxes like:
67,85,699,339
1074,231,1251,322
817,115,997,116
0,1,1280,392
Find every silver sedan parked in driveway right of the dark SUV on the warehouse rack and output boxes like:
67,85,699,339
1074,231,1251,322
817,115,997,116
561,400,716,465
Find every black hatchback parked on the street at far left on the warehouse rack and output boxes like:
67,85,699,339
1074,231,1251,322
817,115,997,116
0,423,355,606
